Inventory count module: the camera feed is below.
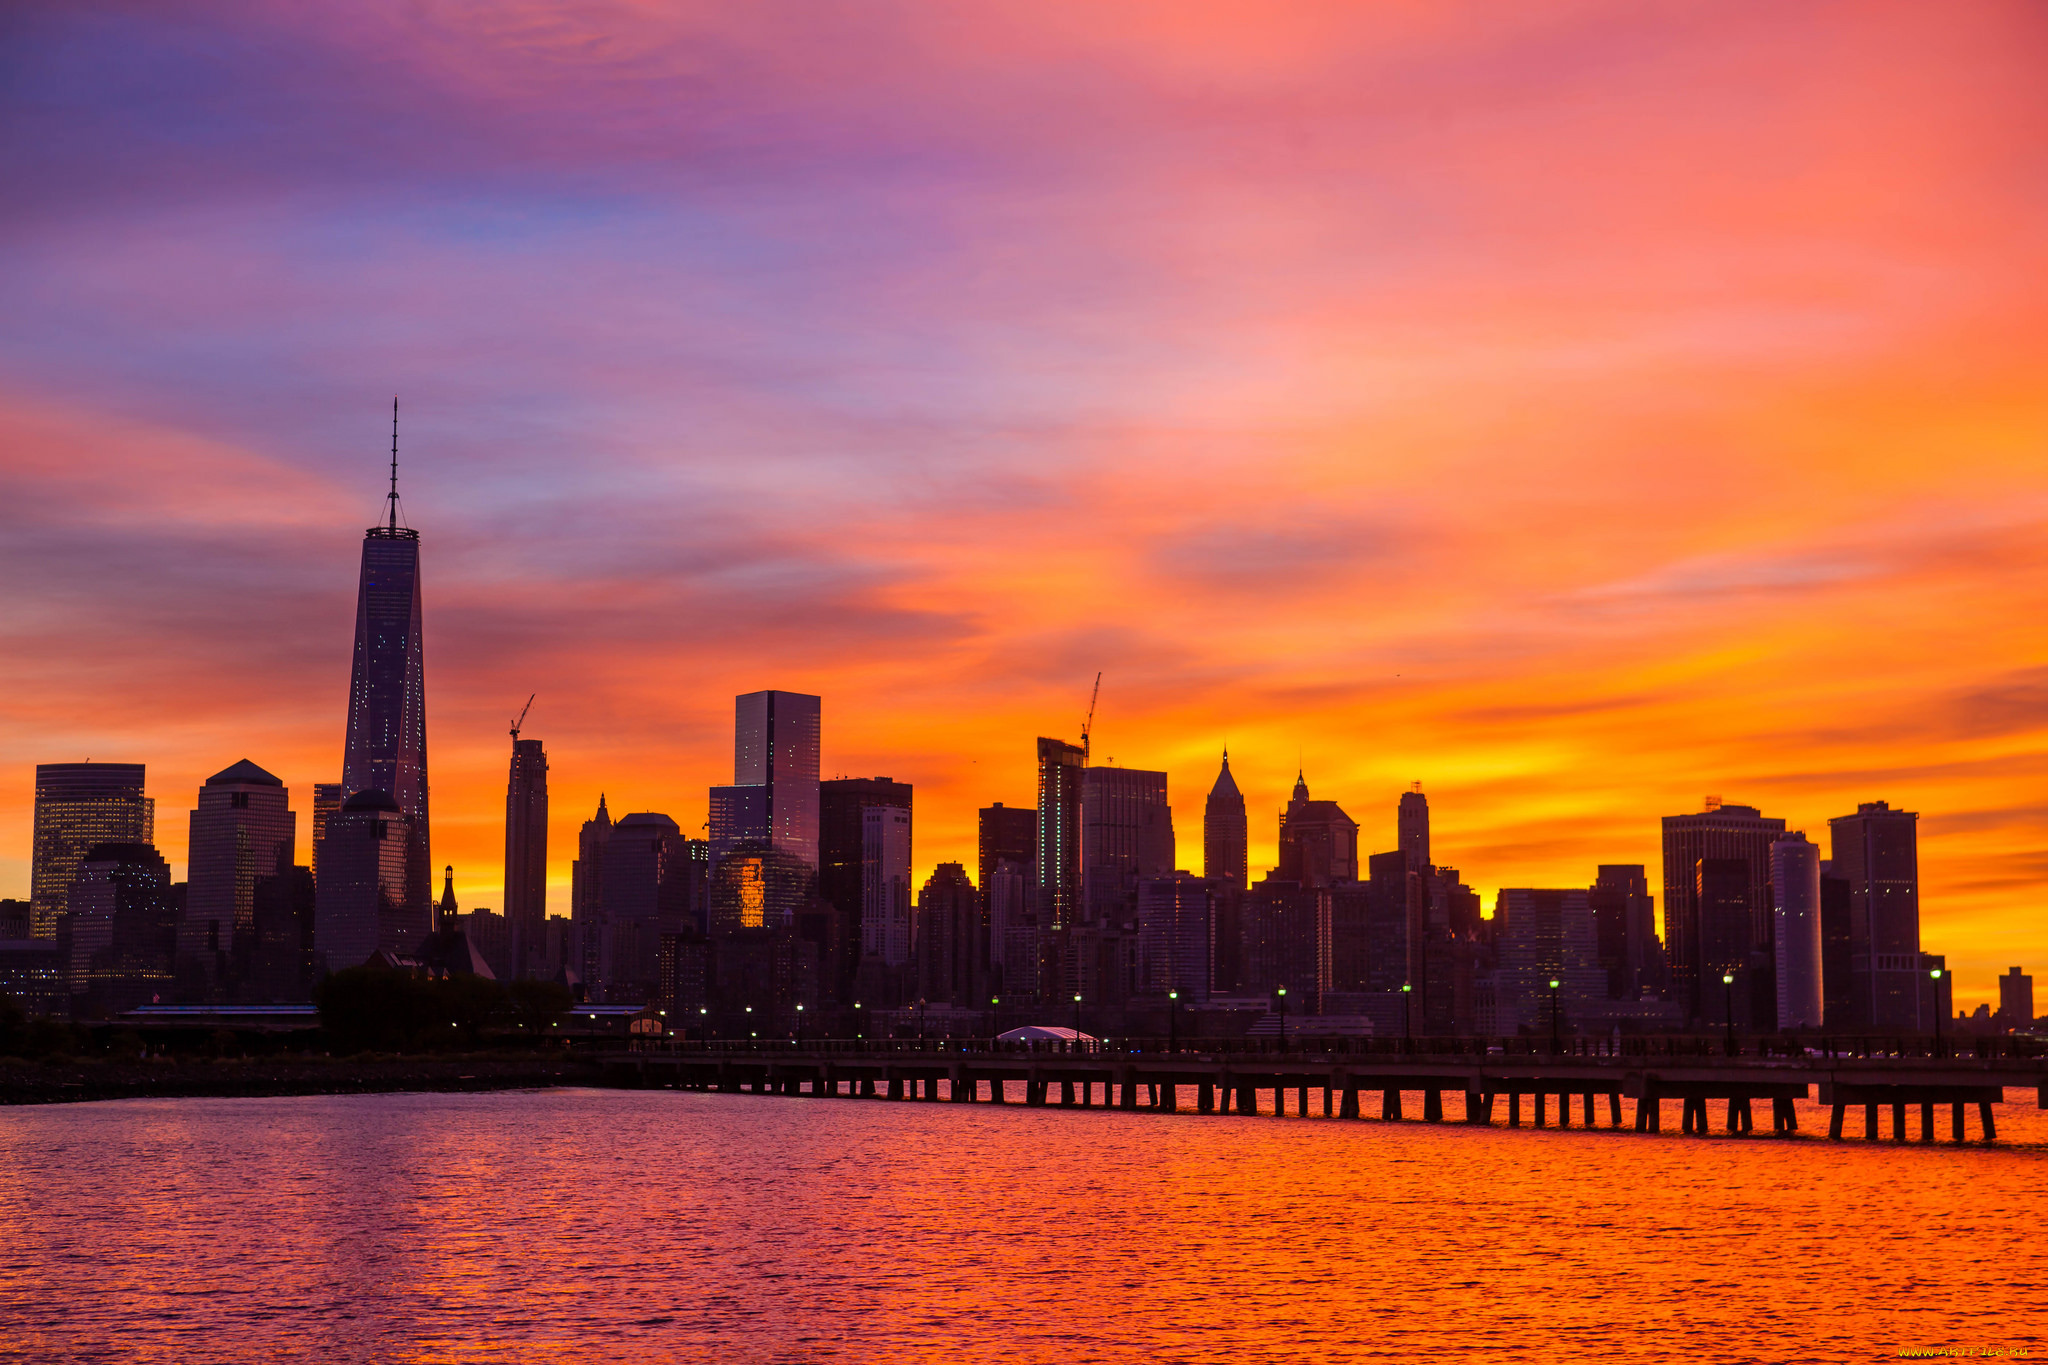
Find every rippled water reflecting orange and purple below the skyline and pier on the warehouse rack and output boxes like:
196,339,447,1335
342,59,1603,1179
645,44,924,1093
0,1091,2048,1365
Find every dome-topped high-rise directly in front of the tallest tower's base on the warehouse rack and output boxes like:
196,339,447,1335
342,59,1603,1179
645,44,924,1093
313,790,417,972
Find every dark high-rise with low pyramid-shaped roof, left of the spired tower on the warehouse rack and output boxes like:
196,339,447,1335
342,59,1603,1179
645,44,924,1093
178,759,299,982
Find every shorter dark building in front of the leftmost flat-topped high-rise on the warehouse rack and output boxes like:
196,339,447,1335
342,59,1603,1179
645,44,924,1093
70,843,178,1013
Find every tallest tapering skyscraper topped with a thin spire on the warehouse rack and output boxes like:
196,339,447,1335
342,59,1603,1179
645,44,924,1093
342,399,434,925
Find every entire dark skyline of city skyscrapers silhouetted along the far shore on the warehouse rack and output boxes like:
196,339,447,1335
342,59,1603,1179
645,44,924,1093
0,442,2032,1033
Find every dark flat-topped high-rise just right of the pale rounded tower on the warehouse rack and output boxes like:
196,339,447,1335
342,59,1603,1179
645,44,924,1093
1827,800,1933,1031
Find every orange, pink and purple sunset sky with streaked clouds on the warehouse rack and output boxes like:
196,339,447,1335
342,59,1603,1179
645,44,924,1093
0,0,2048,1007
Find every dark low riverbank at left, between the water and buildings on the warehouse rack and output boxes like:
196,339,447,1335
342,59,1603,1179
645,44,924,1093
0,1052,602,1105
